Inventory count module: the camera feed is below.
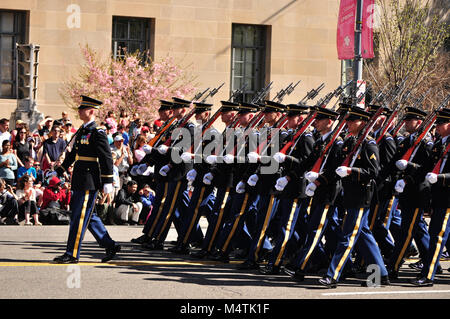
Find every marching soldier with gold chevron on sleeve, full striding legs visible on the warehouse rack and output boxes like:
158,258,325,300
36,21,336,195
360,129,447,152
319,108,389,288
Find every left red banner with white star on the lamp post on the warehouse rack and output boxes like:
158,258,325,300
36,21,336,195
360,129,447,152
336,0,356,60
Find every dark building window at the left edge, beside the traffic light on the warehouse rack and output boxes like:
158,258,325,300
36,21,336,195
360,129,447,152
0,10,27,98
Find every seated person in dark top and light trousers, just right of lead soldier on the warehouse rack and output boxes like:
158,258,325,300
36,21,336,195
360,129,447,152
114,180,142,225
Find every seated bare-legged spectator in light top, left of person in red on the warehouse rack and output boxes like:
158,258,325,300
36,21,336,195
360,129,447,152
16,175,42,226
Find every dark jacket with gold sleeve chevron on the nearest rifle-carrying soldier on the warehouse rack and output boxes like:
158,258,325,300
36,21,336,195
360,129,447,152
338,136,380,208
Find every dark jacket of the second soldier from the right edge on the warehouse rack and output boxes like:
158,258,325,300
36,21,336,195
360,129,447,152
393,135,433,208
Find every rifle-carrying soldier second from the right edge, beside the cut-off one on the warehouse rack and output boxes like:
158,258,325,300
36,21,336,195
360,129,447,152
388,107,433,279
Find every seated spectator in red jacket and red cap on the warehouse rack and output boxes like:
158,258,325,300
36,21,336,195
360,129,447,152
41,176,71,210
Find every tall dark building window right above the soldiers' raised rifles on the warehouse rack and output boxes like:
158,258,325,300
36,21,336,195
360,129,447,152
231,24,269,102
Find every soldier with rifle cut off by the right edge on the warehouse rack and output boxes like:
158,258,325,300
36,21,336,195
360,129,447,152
412,109,450,287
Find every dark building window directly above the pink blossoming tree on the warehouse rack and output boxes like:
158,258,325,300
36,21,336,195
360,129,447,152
112,17,154,58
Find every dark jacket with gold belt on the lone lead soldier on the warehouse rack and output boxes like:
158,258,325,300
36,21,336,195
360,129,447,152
57,122,113,191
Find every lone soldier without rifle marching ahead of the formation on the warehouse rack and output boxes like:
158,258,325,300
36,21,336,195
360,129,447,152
54,96,121,264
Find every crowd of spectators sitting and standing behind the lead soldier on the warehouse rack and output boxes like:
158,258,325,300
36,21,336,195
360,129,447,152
0,112,156,225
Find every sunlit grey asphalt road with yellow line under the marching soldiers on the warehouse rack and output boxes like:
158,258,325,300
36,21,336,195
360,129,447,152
0,220,450,302
